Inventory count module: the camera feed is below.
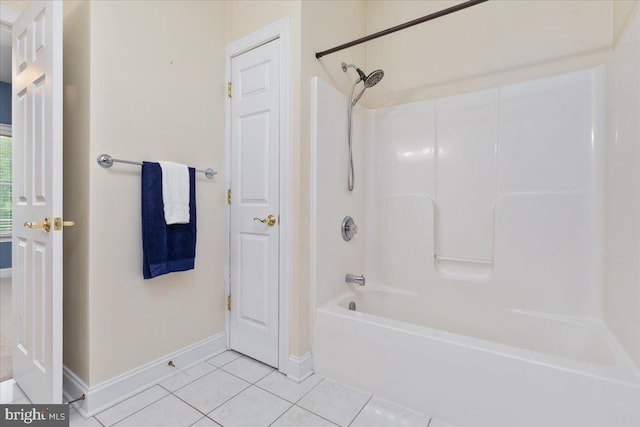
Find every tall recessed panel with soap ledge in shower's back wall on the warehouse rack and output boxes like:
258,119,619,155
432,89,499,281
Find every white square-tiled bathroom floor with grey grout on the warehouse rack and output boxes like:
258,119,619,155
0,351,450,427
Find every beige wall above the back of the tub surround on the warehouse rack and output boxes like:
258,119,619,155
366,0,613,108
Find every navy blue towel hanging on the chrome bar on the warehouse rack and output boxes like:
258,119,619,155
142,162,196,279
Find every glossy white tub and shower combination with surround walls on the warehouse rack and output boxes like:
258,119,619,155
312,13,640,426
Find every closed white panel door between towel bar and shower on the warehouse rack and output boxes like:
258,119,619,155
229,39,280,368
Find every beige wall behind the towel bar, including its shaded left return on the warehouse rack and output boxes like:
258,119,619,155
59,1,225,385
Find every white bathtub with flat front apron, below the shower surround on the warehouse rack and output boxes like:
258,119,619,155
313,288,640,426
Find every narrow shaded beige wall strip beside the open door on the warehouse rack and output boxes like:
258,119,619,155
63,3,94,379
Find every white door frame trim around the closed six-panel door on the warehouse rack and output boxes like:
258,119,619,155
224,17,293,374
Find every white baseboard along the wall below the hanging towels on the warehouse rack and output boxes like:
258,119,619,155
63,332,227,418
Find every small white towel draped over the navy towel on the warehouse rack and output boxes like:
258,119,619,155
159,162,190,225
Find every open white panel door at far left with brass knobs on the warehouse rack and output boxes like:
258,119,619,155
12,1,62,403
